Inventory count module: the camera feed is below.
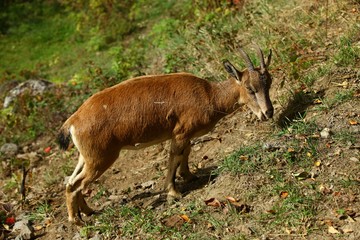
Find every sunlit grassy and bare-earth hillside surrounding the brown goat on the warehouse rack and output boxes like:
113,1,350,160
0,0,360,239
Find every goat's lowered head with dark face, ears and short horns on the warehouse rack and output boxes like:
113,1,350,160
224,45,274,121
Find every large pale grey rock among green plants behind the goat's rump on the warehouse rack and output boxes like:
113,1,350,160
3,80,53,108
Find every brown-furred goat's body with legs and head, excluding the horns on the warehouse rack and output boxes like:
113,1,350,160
59,49,273,224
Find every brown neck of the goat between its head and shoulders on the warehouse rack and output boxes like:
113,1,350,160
213,78,240,115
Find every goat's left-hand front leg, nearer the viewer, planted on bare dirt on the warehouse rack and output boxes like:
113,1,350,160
165,136,190,201
